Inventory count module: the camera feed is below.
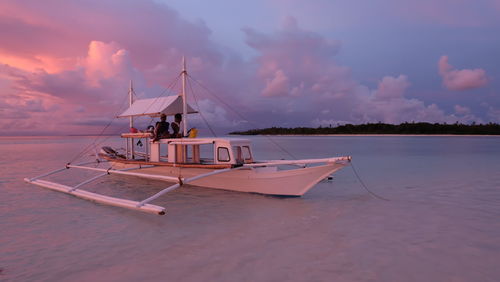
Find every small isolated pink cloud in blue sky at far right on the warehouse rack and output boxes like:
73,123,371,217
438,56,488,91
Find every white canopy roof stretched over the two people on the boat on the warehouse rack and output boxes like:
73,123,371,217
118,96,197,117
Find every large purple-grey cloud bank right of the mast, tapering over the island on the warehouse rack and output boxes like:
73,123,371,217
245,19,482,126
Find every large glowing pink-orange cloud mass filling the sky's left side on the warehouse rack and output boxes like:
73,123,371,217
0,0,230,134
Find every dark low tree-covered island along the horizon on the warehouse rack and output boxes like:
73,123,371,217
229,122,500,135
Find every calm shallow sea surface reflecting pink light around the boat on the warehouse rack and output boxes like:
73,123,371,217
0,136,500,282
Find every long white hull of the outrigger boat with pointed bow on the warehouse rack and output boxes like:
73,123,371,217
113,162,347,196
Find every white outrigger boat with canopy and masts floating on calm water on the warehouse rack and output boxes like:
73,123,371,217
25,59,351,215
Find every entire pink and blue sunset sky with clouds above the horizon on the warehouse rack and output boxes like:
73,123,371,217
0,0,500,135
